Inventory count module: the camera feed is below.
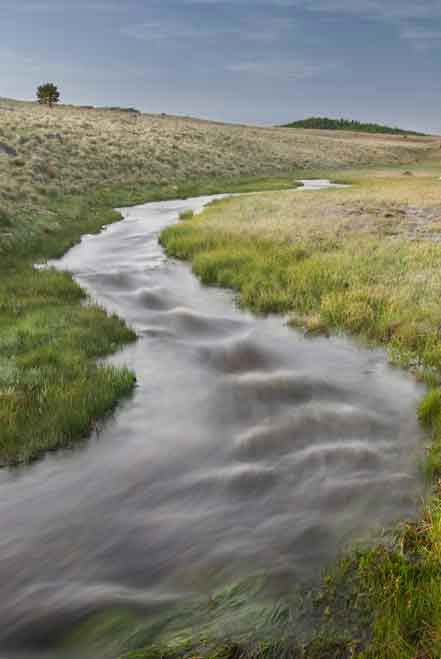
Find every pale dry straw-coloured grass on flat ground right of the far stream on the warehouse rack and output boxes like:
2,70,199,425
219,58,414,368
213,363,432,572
192,175,441,244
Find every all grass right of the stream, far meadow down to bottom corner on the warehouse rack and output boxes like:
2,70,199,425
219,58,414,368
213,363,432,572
161,171,441,659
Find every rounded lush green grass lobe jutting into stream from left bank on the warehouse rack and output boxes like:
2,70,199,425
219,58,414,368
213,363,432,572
0,264,135,466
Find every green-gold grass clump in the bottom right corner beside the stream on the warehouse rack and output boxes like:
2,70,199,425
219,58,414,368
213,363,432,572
357,498,441,659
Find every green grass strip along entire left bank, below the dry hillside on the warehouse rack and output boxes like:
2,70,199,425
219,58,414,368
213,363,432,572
0,176,306,466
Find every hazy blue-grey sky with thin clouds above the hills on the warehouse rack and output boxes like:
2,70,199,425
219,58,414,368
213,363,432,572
0,0,441,133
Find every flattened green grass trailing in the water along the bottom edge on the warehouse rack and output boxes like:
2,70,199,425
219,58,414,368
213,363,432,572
59,561,368,659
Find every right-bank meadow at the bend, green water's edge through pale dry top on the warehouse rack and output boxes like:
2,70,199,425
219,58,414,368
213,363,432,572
161,178,441,370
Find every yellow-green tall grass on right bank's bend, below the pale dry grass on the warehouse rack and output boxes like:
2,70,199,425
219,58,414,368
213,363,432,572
161,217,441,369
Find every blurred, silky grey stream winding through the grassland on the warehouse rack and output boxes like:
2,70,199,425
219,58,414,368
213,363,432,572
0,184,423,659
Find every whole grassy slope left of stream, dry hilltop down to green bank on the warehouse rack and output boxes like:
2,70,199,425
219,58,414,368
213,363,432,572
0,99,439,465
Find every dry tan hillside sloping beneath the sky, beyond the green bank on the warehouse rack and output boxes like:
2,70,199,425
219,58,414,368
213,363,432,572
0,99,434,251
